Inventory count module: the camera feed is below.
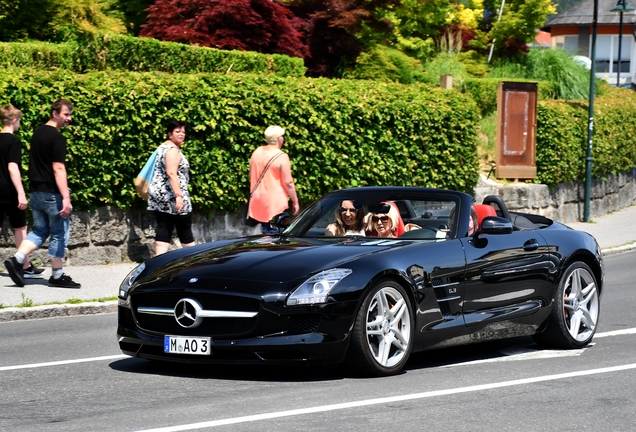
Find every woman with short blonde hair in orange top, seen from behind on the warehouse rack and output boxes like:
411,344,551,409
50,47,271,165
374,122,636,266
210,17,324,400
248,126,300,234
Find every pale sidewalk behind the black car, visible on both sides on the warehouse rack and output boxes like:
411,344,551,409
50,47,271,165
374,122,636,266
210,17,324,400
0,205,636,322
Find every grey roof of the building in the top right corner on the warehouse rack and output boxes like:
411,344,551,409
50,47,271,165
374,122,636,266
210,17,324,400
542,0,636,30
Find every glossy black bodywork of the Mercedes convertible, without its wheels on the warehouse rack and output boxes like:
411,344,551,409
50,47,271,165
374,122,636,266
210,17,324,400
117,187,604,372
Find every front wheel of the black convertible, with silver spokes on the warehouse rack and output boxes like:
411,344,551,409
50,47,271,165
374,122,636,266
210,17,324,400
346,279,413,376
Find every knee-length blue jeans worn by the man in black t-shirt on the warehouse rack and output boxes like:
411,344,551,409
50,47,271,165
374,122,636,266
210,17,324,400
26,192,71,259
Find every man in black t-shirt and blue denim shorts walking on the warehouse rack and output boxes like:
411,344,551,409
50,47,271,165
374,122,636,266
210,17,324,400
4,99,81,288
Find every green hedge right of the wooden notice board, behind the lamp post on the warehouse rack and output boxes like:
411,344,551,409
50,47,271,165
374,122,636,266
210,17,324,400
535,89,636,186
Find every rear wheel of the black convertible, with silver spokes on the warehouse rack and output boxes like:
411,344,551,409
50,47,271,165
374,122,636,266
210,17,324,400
534,262,600,349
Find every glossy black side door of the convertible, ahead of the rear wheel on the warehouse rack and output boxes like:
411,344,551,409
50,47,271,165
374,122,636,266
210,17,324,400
461,230,558,326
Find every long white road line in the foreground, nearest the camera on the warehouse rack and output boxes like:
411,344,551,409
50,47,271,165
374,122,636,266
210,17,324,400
135,363,636,432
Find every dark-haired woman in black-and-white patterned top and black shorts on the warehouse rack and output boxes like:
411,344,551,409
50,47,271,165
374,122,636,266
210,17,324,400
148,120,195,255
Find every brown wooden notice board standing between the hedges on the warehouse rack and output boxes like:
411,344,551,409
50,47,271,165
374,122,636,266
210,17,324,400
495,81,537,179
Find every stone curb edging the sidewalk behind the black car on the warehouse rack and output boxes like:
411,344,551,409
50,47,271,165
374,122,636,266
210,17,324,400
0,242,636,322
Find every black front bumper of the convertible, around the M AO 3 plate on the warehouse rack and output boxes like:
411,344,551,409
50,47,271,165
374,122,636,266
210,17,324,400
117,301,355,364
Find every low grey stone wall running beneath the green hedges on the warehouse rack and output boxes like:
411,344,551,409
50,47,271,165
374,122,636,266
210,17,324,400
0,169,636,265
